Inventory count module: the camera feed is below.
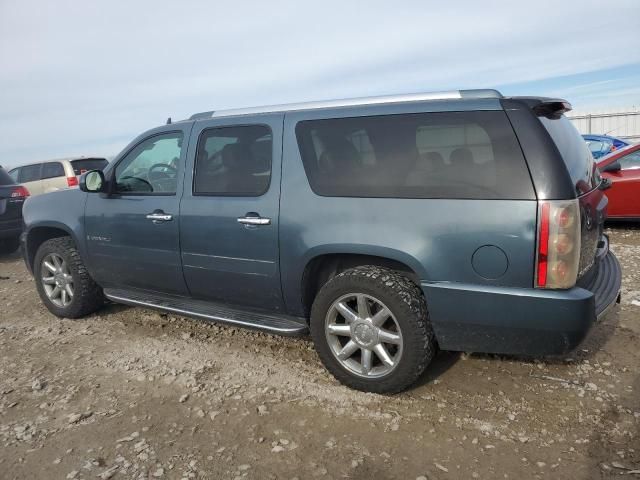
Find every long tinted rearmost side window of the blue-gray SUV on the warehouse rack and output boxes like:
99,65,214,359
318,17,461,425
296,111,535,199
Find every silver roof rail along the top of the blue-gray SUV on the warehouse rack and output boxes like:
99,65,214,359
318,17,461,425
189,89,503,120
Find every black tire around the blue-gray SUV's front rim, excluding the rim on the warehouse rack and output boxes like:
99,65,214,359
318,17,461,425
33,237,104,318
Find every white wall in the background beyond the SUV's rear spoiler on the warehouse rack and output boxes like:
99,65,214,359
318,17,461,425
567,107,640,143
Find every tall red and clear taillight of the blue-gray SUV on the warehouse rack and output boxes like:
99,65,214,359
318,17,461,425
536,200,580,288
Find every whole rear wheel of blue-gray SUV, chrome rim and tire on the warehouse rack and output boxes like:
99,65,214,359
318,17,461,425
311,266,436,393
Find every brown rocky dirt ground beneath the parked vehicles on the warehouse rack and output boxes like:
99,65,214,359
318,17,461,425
0,225,640,480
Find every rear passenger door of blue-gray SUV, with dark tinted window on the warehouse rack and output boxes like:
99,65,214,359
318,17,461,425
180,114,283,311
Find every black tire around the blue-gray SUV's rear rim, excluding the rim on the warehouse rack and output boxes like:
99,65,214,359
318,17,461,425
310,265,437,393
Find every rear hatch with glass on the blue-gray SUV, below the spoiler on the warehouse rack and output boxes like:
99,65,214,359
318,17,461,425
539,115,608,283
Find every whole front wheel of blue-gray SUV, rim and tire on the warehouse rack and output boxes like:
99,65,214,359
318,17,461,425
34,237,104,318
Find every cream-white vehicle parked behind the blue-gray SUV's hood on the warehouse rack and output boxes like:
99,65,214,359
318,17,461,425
9,157,109,195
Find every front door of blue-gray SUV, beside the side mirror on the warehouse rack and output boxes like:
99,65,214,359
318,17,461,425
85,124,191,296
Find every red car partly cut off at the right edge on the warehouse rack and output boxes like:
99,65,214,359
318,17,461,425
598,144,640,220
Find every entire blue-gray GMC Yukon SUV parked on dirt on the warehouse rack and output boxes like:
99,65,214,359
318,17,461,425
22,90,621,393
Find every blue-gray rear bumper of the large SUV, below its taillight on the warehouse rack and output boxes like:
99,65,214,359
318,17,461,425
421,252,622,355
